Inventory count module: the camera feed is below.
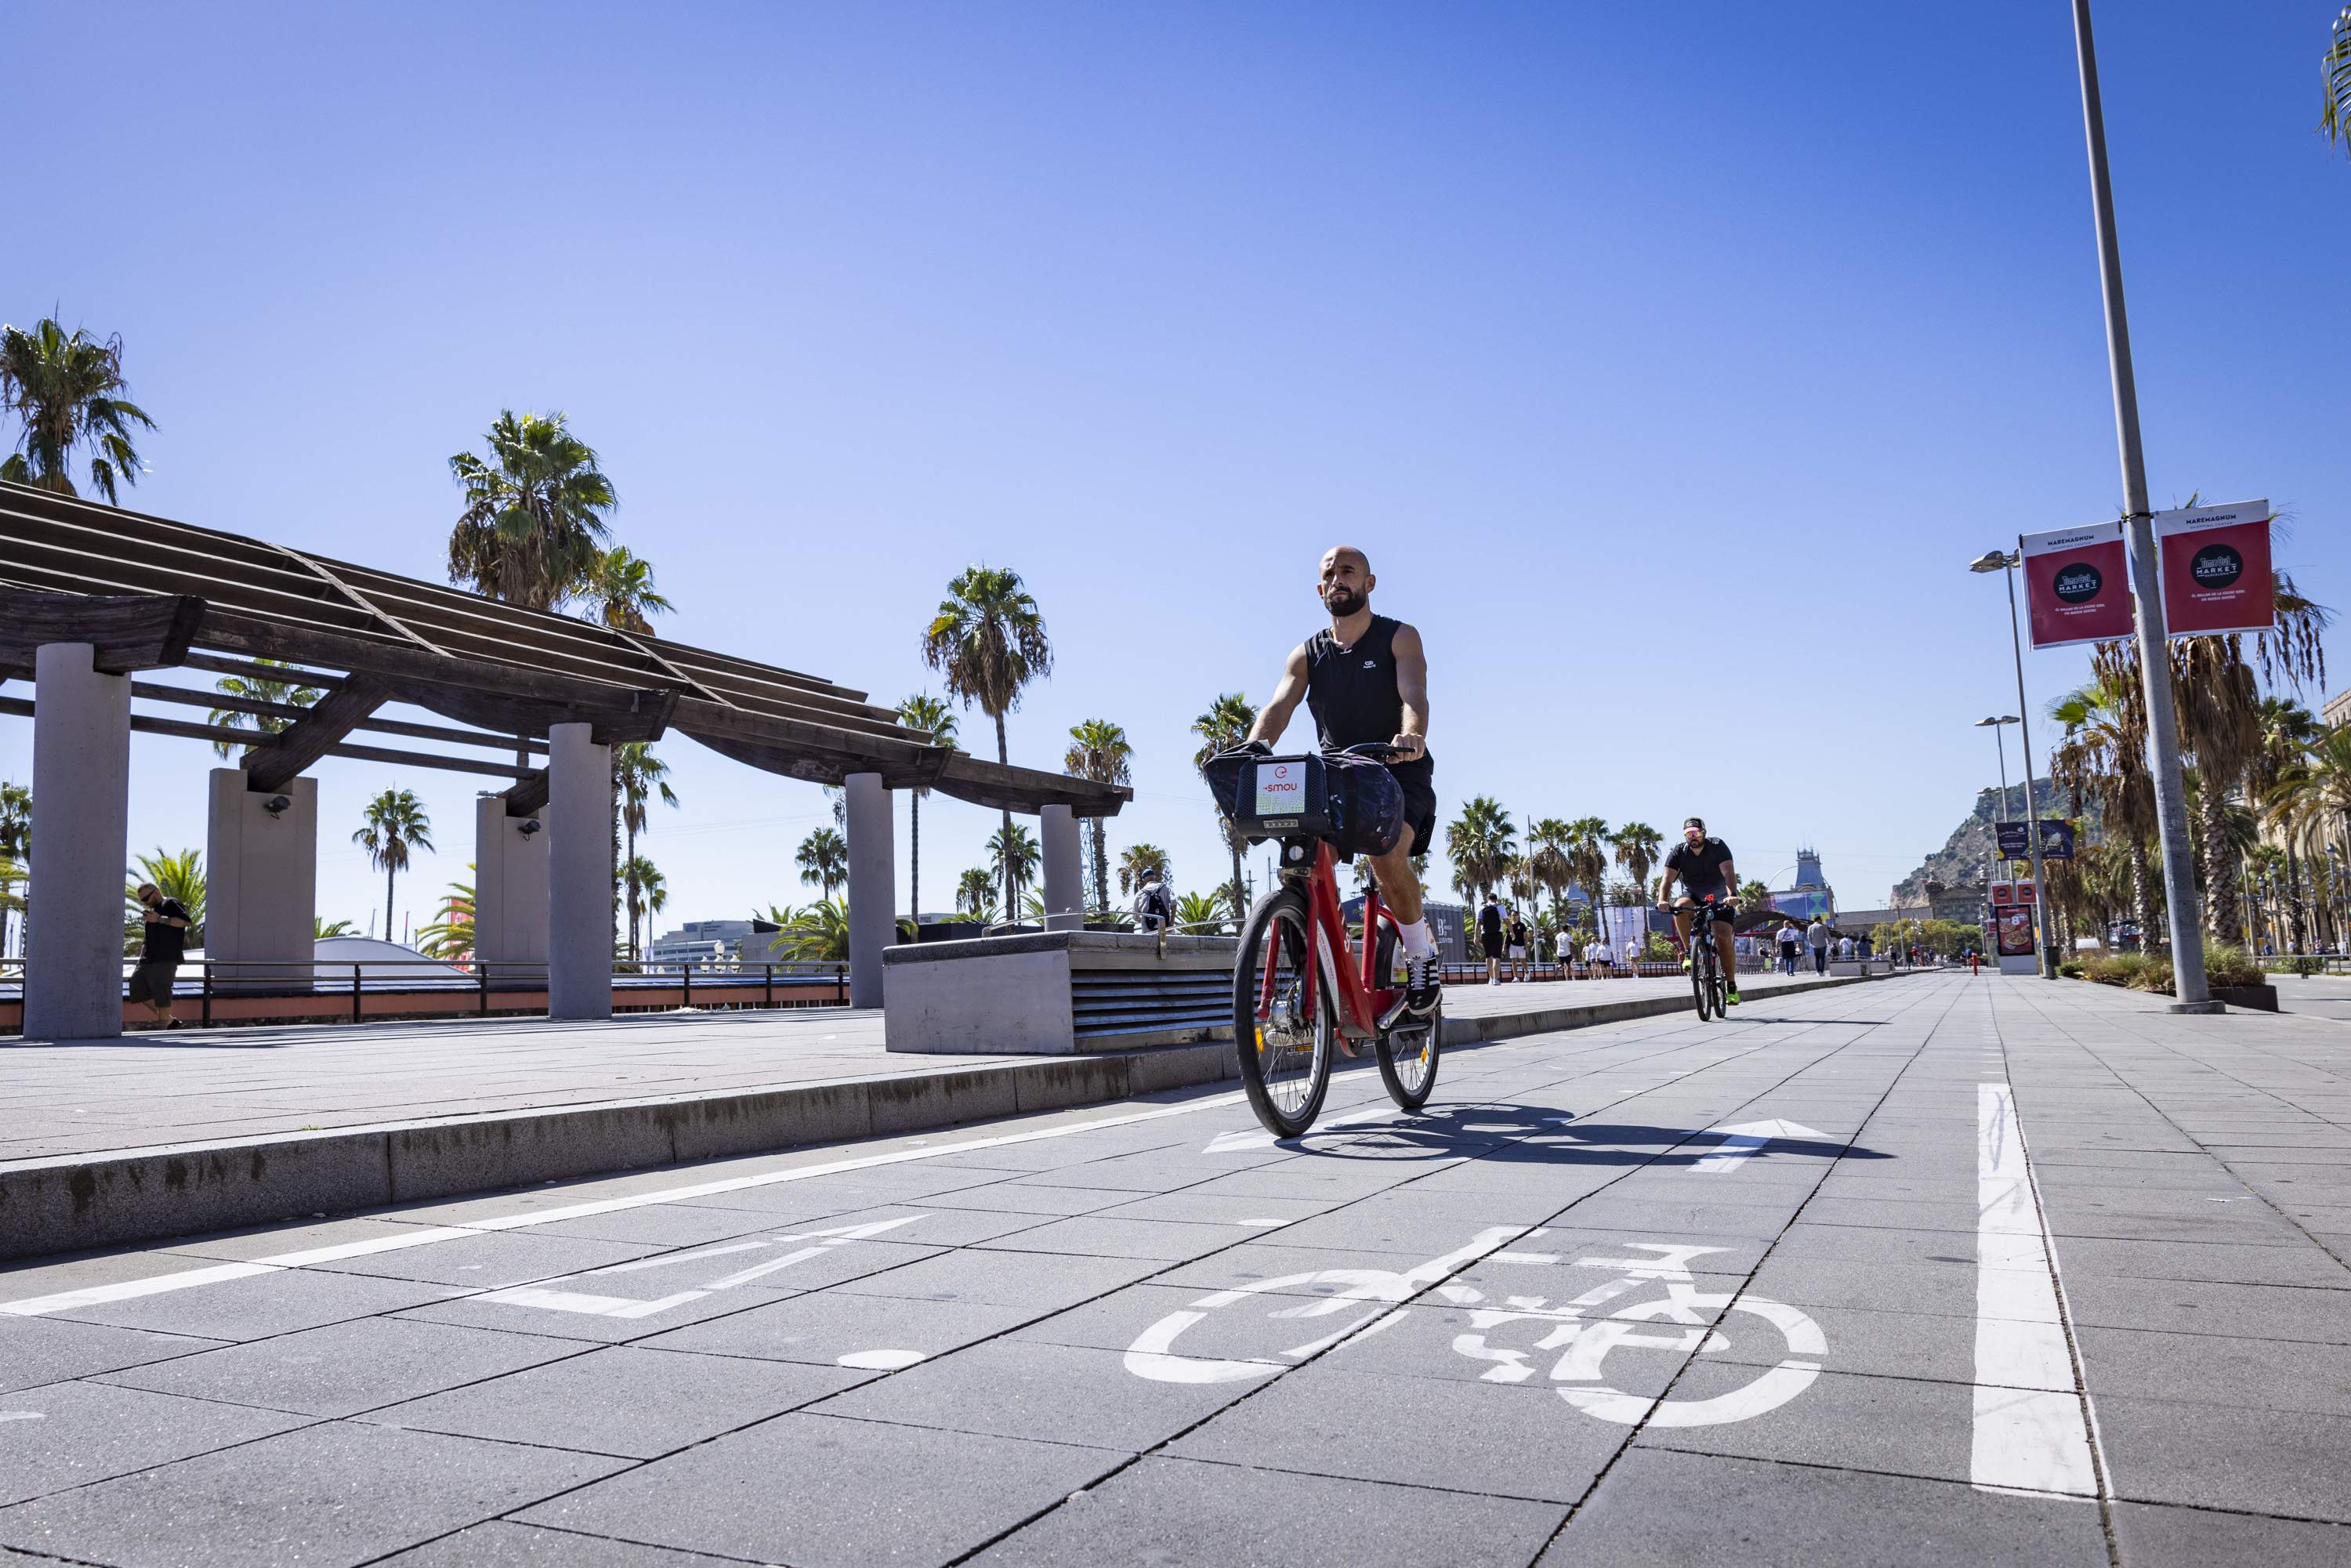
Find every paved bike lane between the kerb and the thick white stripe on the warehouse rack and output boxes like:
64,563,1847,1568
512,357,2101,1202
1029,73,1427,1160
0,980,2172,1563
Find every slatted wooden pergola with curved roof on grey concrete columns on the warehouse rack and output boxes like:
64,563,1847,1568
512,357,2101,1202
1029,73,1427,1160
0,484,1131,1034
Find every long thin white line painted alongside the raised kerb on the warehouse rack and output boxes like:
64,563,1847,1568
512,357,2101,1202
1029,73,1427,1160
0,1093,1246,1316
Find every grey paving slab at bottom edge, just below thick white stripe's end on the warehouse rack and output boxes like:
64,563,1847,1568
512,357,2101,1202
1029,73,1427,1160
1540,1448,2106,1568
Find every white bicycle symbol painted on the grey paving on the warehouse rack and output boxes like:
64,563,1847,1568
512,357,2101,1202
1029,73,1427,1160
1126,1227,1827,1427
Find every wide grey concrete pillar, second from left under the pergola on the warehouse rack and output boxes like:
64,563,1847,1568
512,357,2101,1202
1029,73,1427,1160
205,769,317,990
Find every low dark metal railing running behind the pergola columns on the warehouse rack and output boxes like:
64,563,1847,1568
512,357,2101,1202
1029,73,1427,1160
0,957,849,1034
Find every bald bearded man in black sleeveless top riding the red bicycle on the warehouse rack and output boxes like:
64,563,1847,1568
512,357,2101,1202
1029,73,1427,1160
1248,545,1439,1013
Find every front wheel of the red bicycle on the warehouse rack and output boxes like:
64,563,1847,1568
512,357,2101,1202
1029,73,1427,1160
1232,889,1338,1138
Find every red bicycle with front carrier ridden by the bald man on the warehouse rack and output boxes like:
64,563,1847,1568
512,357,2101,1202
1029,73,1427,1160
1232,745,1444,1138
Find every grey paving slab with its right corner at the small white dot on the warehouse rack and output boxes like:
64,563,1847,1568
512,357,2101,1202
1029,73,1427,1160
367,1335,875,1460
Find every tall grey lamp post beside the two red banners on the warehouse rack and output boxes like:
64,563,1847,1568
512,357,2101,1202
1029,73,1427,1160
2069,0,2226,1013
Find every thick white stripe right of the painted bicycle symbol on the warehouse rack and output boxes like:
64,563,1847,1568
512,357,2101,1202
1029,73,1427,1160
1968,1084,2097,1497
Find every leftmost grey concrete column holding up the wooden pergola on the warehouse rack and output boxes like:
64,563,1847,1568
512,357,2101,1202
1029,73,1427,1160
24,642,132,1039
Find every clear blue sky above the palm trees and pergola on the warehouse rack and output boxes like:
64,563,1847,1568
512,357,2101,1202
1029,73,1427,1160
0,0,2351,924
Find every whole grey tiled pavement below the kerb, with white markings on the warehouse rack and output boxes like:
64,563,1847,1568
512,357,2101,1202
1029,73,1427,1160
0,976,2351,1568
